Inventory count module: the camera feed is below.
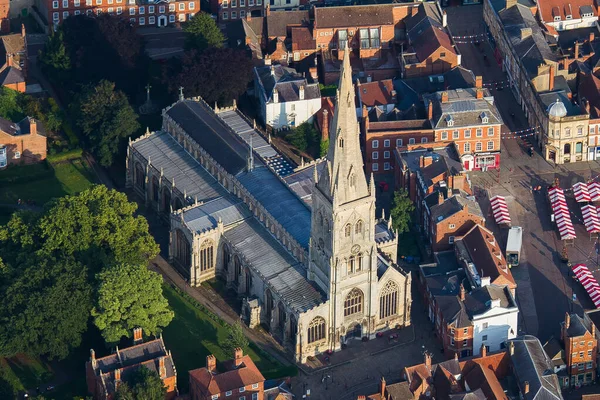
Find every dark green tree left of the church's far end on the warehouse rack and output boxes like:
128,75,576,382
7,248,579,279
73,81,140,167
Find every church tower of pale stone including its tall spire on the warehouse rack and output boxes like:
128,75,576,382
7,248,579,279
308,51,377,342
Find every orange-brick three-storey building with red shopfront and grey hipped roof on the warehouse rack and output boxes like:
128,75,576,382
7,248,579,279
425,83,503,171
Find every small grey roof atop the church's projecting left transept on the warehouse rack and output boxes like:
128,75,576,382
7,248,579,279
183,195,252,232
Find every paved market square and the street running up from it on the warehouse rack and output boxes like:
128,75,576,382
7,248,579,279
447,6,600,343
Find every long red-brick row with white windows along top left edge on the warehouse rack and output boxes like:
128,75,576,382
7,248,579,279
36,0,200,29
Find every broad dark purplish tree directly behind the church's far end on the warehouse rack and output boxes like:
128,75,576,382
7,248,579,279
163,48,252,104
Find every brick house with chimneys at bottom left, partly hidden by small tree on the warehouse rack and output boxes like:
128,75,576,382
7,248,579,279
85,328,178,400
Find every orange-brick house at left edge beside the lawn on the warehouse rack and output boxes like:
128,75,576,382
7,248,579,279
0,117,46,168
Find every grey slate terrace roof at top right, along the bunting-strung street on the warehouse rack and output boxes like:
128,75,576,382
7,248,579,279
498,4,557,79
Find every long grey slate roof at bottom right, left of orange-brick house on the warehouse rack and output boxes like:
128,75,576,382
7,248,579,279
510,335,563,400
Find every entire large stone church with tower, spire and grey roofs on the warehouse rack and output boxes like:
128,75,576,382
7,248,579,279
126,52,411,363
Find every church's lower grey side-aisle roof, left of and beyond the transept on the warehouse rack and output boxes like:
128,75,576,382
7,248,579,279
133,132,227,204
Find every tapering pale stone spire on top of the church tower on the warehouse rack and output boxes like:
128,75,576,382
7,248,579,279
317,45,370,205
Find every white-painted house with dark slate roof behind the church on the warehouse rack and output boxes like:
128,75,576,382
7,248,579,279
254,64,321,130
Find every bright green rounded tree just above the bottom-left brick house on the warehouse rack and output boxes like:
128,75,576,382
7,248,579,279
92,264,174,343
